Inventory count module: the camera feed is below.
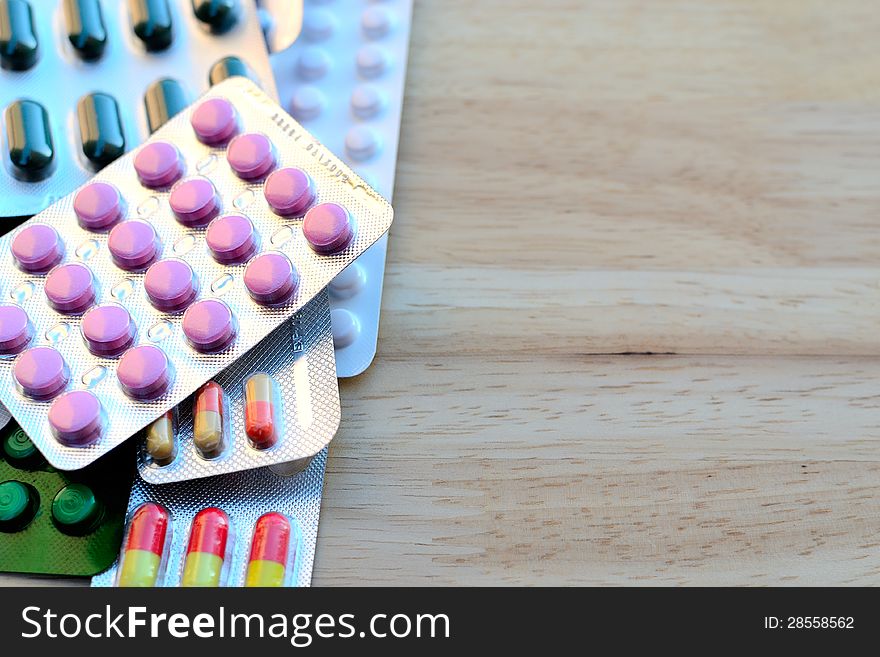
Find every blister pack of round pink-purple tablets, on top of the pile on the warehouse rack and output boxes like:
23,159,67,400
0,77,393,470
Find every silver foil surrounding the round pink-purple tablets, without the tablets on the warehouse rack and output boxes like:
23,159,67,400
0,77,393,470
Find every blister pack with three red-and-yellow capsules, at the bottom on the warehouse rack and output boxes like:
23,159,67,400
92,449,327,587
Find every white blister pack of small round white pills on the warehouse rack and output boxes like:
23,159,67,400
271,0,412,377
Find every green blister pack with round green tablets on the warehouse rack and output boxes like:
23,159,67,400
0,420,135,576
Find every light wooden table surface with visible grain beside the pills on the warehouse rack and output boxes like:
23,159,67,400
6,0,880,586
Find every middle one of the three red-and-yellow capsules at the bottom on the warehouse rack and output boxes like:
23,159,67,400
180,507,229,587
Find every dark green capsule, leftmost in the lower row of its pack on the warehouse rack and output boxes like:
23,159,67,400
6,100,55,181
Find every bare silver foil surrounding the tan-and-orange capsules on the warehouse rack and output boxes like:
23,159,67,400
138,292,340,484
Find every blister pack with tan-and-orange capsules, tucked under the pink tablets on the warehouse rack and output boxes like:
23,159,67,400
138,291,340,484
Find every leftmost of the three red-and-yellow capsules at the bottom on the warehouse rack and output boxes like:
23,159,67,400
116,502,171,587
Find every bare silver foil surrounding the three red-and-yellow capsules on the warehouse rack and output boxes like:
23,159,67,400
92,449,327,587
